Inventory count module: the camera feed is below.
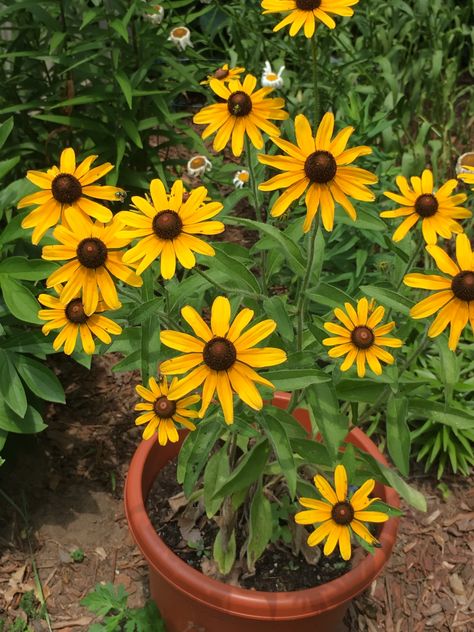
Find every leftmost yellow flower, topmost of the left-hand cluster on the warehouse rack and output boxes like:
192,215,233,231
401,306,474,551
18,147,124,244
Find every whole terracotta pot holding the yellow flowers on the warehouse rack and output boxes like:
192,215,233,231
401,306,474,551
125,393,399,632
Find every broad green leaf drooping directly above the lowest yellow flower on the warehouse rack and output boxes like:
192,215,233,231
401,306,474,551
305,384,349,457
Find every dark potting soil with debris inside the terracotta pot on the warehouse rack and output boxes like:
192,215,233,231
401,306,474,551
147,460,350,592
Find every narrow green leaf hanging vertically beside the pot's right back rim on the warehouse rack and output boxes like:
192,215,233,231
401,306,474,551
387,393,411,476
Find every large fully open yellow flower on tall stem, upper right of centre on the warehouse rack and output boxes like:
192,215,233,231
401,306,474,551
258,112,377,233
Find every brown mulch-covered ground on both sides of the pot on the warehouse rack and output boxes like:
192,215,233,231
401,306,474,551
0,356,474,632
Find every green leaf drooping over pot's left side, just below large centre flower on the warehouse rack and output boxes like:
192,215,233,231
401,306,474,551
177,416,222,498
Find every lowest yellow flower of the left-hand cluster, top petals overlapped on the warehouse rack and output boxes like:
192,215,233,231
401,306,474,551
38,294,122,355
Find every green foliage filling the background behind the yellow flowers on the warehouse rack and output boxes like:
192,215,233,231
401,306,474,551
0,0,474,484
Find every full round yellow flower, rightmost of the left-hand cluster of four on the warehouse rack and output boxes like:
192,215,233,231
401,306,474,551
116,179,225,279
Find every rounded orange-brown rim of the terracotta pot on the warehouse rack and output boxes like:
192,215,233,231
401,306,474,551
124,393,400,620
